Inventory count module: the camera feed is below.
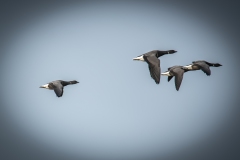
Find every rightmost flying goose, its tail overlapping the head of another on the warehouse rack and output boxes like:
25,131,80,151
184,60,222,76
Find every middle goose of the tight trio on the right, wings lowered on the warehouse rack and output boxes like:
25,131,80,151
161,66,188,91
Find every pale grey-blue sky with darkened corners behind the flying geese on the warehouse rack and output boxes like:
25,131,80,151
0,1,239,159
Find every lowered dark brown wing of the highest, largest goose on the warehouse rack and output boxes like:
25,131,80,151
143,56,161,84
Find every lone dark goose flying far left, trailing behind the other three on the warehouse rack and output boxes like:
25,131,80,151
40,80,79,97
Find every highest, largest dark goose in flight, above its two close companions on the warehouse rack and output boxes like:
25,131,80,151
133,50,177,84
